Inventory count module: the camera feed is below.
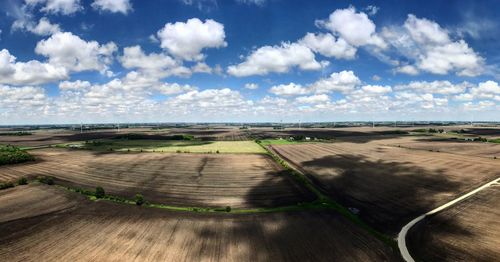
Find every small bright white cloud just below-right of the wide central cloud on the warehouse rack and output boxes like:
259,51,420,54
309,70,361,93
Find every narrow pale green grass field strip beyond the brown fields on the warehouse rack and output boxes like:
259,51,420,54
68,139,265,153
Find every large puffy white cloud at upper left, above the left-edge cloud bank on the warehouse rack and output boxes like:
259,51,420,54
35,32,117,72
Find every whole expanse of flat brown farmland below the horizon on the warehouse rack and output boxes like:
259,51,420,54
0,127,500,261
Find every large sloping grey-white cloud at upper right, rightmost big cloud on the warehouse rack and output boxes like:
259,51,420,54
382,14,484,76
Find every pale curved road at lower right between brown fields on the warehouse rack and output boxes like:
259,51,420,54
398,177,500,262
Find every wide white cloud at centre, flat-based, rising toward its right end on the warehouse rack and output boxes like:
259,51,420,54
227,43,322,77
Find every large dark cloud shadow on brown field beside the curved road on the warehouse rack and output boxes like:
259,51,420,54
300,154,467,235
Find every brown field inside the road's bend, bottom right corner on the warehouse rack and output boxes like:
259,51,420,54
408,185,500,261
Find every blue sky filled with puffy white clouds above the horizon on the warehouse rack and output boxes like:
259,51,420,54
0,0,500,125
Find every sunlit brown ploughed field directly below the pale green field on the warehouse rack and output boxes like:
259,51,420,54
0,148,314,208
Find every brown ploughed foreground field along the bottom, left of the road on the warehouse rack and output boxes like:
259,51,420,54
0,186,398,261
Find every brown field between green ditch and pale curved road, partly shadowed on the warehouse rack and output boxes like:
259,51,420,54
272,142,500,235
